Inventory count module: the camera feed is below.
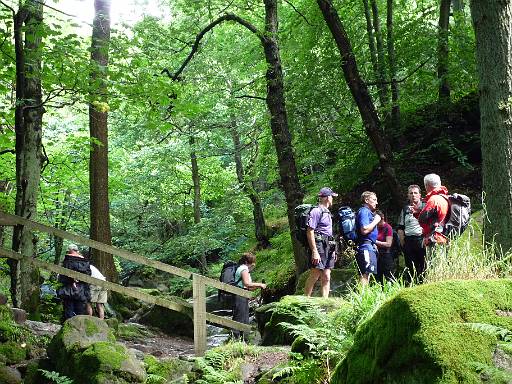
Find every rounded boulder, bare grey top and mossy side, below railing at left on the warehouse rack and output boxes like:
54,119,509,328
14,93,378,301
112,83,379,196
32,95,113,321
47,316,146,384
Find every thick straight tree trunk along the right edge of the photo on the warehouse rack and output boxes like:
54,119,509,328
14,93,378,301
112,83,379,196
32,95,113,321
470,0,512,254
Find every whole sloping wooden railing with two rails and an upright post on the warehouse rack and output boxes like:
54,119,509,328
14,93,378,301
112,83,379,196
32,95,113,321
0,211,252,356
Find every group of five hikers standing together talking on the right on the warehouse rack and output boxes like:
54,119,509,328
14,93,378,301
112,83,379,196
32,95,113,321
304,173,456,297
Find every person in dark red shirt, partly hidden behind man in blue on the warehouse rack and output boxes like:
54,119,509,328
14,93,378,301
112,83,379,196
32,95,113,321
375,209,395,283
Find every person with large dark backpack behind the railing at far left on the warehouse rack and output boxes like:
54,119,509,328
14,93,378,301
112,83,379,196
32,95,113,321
57,244,91,320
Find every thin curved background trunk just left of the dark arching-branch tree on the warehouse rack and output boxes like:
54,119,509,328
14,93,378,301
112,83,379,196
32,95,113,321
231,121,270,248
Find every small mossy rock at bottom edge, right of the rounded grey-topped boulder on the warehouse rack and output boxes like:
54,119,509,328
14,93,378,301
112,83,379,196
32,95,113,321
144,355,194,383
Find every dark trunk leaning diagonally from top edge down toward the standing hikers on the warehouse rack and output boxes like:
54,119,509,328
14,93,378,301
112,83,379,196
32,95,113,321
317,0,403,205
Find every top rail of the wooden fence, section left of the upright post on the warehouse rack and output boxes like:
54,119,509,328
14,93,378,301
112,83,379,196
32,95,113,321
0,211,192,279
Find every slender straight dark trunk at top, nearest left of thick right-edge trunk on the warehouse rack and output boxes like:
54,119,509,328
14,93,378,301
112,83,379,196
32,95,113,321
437,0,451,105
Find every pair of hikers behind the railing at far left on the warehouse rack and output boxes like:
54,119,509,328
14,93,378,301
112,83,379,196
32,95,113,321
57,244,107,320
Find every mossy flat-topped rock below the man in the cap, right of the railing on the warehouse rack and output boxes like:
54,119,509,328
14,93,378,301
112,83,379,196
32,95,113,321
256,296,344,345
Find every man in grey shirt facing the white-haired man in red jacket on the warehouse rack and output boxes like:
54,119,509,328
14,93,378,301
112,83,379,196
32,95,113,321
398,184,425,282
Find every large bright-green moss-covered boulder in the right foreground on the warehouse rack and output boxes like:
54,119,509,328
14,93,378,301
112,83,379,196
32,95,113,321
332,279,512,384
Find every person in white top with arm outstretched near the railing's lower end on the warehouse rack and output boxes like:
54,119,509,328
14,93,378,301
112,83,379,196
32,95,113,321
233,252,267,340
